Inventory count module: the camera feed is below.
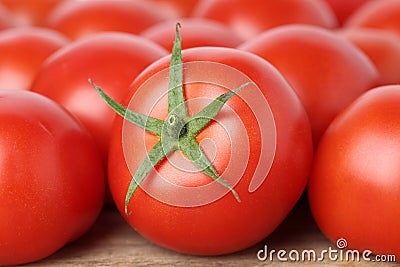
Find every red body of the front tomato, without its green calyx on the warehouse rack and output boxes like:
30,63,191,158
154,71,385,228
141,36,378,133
108,47,313,255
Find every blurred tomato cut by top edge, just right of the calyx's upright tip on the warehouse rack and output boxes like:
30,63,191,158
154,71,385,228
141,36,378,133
193,0,337,40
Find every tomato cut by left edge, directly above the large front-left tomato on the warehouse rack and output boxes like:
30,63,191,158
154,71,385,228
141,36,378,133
0,27,69,90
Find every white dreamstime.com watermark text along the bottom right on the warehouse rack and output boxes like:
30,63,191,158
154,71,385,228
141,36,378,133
257,238,396,262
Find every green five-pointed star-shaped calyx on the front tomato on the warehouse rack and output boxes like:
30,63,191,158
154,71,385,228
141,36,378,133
89,23,254,215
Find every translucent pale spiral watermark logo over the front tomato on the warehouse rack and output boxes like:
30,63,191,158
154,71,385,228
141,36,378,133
122,61,276,207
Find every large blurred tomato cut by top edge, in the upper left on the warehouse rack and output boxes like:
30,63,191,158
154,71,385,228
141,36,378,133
45,0,163,39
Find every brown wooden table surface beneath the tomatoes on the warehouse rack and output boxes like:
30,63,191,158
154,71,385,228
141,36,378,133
26,199,400,267
